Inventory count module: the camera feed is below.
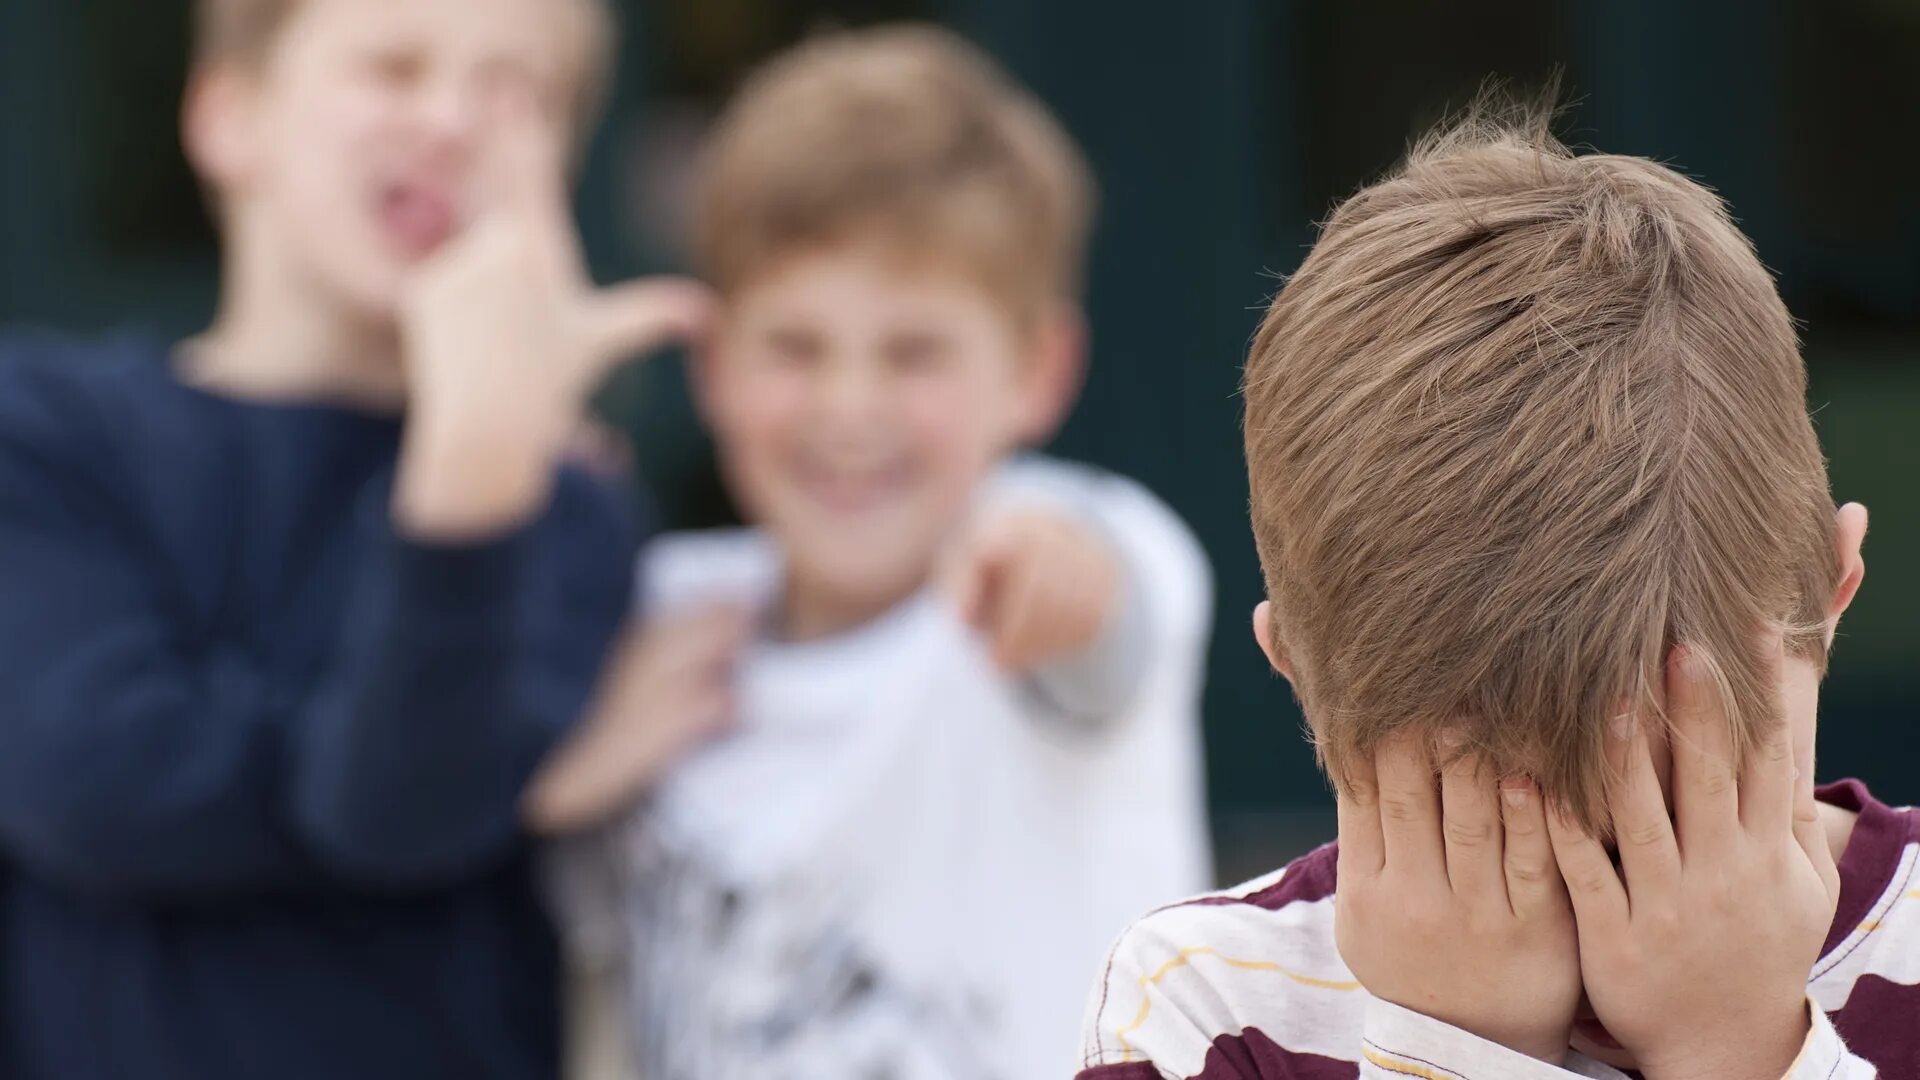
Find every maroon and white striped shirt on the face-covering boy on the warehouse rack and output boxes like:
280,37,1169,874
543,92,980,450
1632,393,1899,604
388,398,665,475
1079,780,1920,1080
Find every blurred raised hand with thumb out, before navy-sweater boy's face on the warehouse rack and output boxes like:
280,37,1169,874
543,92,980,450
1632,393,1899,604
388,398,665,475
396,91,710,536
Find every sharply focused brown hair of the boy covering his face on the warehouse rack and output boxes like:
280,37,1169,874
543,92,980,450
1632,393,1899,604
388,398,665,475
1246,110,1837,830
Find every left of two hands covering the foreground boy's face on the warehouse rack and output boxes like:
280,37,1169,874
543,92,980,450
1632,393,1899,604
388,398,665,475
1334,734,1580,1065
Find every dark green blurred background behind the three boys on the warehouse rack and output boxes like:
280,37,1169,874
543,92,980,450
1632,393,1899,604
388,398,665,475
0,0,1920,876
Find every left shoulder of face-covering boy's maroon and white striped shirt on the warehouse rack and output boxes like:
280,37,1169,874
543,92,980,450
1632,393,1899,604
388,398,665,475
1081,844,1365,1080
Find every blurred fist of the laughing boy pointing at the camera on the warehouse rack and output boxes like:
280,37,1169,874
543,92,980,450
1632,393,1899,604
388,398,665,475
947,509,1121,671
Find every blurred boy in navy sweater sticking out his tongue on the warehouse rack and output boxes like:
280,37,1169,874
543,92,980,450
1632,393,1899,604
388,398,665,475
0,0,721,1080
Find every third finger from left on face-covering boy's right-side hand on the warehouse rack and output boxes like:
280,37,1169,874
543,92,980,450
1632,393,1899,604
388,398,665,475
1667,646,1740,851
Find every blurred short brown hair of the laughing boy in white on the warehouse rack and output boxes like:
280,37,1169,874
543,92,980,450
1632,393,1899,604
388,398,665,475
693,25,1092,313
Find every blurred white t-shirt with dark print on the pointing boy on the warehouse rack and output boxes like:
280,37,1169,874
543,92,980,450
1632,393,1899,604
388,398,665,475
587,459,1212,1080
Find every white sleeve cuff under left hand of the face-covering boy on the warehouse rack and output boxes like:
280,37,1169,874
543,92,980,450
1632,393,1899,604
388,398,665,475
1359,997,1626,1080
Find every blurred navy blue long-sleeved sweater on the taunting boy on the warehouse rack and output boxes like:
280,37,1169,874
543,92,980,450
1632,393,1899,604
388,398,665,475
0,338,632,1080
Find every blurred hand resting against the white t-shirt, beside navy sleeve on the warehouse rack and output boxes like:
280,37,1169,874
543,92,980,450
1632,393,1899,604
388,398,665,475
522,607,751,834
